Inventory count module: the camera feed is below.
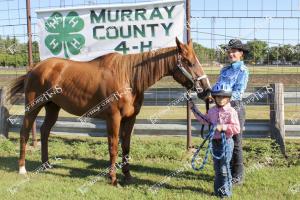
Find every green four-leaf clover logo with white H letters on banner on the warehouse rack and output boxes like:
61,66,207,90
45,11,85,58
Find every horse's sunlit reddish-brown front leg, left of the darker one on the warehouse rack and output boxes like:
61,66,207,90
106,114,121,186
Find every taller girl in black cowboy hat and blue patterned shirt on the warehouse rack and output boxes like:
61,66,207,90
216,39,249,184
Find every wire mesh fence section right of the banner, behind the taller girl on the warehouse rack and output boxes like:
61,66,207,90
191,0,300,130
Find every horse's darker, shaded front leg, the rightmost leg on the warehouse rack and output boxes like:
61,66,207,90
121,116,136,182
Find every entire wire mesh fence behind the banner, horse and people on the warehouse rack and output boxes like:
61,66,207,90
0,0,300,136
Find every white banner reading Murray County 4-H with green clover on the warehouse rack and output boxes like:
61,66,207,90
36,0,185,61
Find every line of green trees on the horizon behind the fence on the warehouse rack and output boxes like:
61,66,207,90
0,36,300,67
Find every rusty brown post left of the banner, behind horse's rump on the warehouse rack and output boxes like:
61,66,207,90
26,0,37,147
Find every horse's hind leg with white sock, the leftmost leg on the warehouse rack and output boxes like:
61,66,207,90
19,105,43,174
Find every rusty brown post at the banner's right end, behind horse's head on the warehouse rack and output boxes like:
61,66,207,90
186,0,192,150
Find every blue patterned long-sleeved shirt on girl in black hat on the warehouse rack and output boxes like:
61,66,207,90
216,61,249,101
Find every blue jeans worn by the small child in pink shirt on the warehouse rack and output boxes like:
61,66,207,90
212,138,233,197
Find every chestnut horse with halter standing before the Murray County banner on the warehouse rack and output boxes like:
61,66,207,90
8,38,210,185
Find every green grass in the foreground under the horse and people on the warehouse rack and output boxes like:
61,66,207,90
0,133,300,200
